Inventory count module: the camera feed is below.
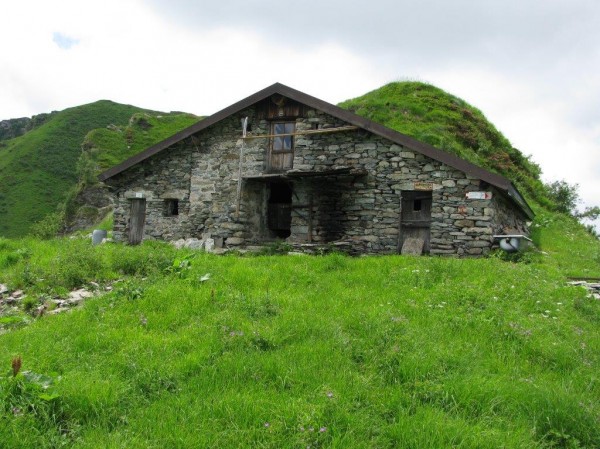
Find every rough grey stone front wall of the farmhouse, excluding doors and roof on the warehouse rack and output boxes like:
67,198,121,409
110,102,526,255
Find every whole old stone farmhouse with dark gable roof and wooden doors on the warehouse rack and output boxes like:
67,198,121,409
99,83,533,256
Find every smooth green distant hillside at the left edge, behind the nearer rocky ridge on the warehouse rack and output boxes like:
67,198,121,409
0,100,146,236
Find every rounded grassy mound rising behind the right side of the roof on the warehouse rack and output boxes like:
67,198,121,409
339,82,547,204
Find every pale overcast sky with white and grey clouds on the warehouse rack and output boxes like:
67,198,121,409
0,0,600,219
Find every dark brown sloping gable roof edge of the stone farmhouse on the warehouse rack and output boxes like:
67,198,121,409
98,83,534,219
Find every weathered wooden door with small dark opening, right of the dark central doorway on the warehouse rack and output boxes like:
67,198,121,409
399,190,432,253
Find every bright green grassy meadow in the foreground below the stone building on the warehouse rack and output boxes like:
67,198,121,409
0,233,600,448
